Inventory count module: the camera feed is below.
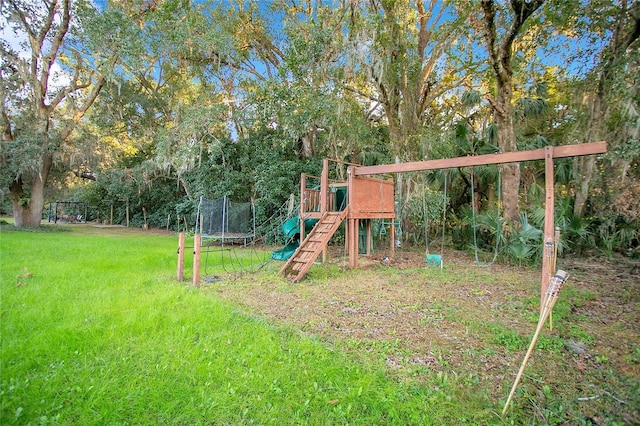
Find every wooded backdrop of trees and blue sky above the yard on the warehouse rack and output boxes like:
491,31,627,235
0,0,640,256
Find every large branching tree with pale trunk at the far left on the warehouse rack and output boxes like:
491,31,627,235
0,0,116,227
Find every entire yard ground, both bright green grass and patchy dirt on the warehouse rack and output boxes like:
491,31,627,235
0,225,640,425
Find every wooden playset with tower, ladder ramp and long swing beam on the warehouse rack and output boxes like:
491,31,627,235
280,142,607,306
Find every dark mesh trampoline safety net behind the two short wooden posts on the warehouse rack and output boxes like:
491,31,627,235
195,197,255,243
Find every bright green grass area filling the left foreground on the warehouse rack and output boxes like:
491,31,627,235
0,226,500,425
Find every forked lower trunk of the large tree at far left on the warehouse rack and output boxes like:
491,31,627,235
9,154,53,228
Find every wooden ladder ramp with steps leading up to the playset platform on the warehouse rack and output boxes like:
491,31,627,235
280,209,348,283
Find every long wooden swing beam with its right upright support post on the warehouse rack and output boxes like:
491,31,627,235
353,142,607,309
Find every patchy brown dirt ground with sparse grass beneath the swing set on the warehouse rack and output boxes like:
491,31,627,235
209,245,640,424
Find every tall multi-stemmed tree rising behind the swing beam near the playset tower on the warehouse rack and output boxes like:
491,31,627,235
345,0,465,160
